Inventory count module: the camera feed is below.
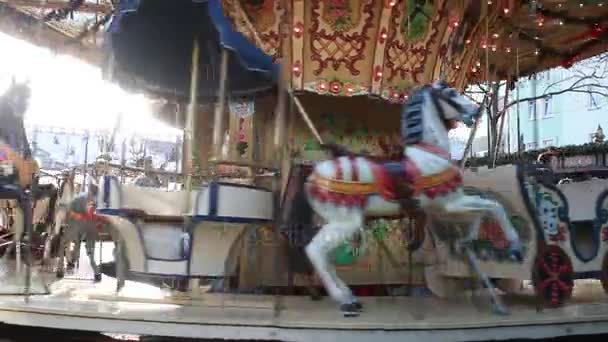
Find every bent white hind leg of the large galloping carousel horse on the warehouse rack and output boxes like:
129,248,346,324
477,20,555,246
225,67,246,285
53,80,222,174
306,210,363,316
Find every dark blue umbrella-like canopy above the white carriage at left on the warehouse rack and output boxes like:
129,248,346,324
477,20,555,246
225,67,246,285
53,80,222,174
105,0,276,99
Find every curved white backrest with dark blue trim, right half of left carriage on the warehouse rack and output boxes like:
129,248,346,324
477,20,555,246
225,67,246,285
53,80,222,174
193,182,274,223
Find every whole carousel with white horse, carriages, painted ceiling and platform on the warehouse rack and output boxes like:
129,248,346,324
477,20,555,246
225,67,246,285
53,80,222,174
0,0,608,341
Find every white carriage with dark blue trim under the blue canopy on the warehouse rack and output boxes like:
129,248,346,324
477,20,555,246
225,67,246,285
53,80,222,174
97,176,274,288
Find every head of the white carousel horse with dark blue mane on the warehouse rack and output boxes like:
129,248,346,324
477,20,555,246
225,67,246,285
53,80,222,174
428,81,481,130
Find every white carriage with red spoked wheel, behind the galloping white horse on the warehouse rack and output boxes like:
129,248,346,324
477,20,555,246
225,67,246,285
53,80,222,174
426,165,608,306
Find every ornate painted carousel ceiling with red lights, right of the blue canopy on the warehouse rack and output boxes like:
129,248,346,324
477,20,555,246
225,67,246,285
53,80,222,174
221,0,608,102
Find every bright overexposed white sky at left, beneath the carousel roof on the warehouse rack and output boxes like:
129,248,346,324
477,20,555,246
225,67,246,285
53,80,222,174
0,33,179,139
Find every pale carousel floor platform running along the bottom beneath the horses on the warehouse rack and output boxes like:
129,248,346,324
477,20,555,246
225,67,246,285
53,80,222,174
0,264,608,342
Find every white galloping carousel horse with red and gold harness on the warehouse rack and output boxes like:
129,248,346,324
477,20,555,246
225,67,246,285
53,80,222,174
305,82,521,316
